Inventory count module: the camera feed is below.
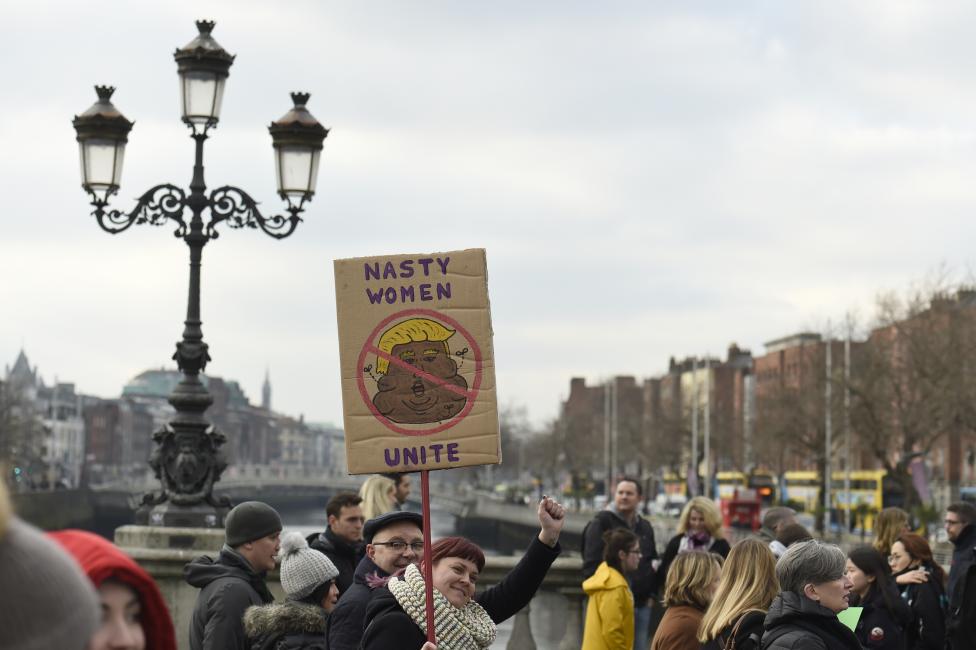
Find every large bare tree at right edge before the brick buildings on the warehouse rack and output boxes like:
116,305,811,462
850,283,976,509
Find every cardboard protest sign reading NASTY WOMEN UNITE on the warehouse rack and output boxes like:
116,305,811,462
335,249,501,474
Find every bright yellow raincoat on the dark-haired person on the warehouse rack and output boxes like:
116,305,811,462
581,562,634,650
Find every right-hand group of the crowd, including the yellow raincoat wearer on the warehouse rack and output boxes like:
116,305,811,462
582,478,976,650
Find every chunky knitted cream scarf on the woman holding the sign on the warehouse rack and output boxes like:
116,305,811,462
386,564,495,650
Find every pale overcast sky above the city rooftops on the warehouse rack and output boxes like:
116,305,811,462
0,0,976,423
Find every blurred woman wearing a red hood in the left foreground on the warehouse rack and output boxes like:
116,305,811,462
48,530,176,650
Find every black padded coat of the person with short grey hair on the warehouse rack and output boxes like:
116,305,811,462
762,591,862,650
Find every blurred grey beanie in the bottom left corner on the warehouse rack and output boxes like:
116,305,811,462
0,516,102,650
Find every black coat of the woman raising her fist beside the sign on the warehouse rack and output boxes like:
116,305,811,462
358,538,561,650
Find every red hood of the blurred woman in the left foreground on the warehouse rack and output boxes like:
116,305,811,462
48,530,176,650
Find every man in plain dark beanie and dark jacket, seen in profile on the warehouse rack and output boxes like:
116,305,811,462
183,501,281,650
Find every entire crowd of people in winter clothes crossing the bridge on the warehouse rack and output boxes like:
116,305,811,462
0,476,976,650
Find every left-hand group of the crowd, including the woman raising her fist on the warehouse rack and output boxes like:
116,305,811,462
0,476,564,650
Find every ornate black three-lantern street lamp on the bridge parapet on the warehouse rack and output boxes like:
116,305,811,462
72,21,329,527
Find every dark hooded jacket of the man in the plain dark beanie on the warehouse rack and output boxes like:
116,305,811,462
183,546,274,650
